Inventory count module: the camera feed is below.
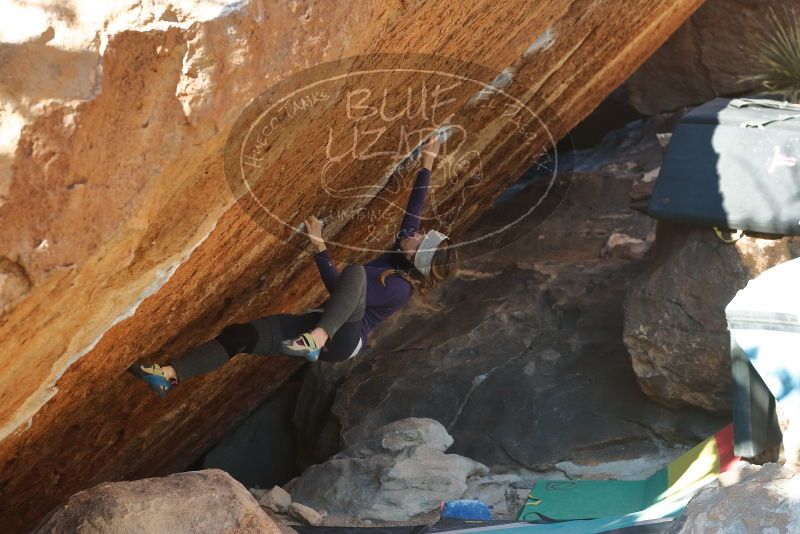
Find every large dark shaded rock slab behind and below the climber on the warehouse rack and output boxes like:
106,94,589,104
295,115,726,480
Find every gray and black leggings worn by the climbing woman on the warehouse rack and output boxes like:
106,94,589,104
170,265,367,382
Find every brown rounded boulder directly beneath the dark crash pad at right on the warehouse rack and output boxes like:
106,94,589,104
624,223,800,412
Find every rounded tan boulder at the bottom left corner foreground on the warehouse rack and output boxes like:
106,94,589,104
34,469,280,534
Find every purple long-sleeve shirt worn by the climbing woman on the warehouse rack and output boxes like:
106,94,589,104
314,167,431,346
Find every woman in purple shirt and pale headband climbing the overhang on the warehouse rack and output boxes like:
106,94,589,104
130,134,456,397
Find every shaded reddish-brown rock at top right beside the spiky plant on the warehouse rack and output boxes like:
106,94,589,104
626,0,797,115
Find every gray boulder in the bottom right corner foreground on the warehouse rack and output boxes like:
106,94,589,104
667,464,800,534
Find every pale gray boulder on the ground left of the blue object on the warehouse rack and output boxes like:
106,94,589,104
292,418,489,524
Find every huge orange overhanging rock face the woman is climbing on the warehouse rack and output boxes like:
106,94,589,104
0,0,702,531
